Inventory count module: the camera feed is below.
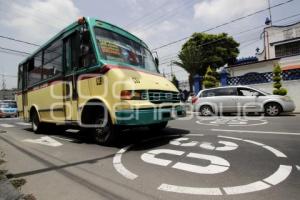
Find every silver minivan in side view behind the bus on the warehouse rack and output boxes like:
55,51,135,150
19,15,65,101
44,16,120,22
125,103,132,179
192,86,295,116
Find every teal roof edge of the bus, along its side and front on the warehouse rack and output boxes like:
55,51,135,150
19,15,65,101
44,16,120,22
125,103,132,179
20,17,148,65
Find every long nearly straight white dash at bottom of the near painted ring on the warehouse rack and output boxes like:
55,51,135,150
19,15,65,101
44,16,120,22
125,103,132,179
157,183,222,195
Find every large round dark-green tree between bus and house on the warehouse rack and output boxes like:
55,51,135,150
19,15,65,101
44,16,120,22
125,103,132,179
174,33,239,91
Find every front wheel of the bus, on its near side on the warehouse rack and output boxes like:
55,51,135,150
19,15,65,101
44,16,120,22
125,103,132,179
92,117,116,145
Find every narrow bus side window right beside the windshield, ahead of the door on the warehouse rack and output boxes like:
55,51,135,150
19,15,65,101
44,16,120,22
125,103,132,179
80,31,96,67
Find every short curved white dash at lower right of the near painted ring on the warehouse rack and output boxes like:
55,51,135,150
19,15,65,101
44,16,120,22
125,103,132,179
264,165,293,185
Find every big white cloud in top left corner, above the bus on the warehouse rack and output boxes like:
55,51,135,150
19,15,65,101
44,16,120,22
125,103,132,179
0,0,79,42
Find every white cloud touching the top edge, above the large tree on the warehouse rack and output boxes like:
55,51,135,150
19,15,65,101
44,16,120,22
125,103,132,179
194,0,267,23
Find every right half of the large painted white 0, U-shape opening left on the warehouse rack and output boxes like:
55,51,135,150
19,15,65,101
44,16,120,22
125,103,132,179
172,153,230,174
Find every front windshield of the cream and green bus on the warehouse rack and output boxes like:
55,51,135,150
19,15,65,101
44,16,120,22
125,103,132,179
95,28,157,72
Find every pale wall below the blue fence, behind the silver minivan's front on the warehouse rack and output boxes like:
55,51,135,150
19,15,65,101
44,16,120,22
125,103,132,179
249,80,300,112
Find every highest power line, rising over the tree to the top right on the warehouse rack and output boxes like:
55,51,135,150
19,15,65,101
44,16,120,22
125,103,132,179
152,0,294,51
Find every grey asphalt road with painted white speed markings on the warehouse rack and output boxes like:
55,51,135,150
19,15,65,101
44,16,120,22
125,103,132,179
0,115,300,200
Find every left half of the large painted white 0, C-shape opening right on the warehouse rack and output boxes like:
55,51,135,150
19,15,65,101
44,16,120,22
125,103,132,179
141,149,185,166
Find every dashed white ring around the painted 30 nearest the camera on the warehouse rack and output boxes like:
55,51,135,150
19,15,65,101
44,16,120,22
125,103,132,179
113,134,292,195
